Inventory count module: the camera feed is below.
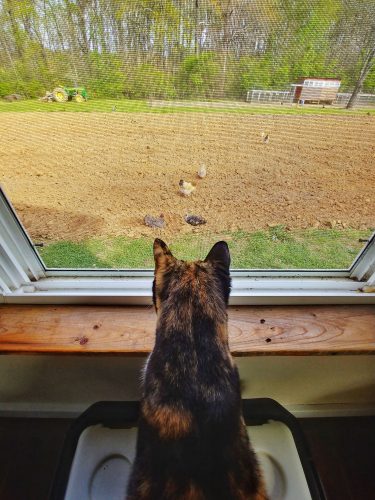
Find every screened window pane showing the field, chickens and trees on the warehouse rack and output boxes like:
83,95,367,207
0,0,375,269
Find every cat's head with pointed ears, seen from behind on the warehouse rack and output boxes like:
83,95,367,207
152,239,231,312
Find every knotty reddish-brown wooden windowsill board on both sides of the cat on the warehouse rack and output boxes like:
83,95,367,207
0,305,375,356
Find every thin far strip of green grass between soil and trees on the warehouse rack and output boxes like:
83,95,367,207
0,99,375,115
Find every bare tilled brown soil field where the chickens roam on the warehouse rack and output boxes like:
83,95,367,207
0,113,375,240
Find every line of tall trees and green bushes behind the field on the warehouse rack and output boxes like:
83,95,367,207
0,0,375,99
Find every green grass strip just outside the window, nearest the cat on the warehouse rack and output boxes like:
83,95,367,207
39,226,372,269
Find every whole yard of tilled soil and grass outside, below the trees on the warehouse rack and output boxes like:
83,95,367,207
0,100,375,268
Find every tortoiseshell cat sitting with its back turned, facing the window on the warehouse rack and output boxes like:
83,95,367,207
127,239,267,500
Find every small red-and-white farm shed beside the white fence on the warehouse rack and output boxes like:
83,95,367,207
292,77,341,104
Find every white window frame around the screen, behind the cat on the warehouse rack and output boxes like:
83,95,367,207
0,186,375,305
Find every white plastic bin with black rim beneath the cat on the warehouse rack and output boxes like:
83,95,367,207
51,399,325,500
